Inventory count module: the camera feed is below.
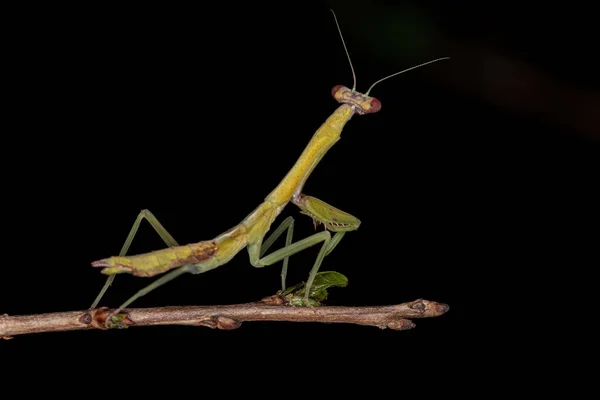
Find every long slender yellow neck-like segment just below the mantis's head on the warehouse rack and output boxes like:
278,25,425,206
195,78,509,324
265,104,355,206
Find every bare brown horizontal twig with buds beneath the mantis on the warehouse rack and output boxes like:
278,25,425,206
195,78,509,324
0,296,449,339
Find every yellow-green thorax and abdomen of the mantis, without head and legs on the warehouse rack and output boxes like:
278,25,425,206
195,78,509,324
92,101,364,277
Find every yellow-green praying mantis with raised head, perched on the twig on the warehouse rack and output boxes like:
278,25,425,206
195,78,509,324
90,10,448,322
